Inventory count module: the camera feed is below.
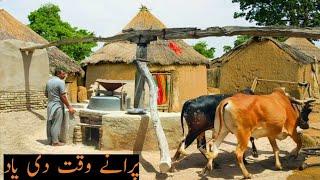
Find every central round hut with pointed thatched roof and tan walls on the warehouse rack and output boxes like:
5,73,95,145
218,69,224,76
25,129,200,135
83,7,208,111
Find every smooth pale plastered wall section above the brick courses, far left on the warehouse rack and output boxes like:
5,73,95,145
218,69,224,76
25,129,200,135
0,40,49,91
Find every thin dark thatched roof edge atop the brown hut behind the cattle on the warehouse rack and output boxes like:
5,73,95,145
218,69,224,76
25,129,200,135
210,37,314,67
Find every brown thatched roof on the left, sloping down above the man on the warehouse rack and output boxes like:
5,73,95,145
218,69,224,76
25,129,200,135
0,9,84,75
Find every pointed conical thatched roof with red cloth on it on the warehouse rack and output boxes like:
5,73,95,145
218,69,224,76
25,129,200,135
83,7,208,65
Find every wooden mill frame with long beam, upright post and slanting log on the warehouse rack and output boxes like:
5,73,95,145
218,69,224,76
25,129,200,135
20,26,320,172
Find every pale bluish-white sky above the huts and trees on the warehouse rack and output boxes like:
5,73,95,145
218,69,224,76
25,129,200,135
0,0,254,57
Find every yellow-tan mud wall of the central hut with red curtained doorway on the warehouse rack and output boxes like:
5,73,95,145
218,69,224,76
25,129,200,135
86,64,207,112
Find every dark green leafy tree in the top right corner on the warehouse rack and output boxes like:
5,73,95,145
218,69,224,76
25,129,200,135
232,0,320,27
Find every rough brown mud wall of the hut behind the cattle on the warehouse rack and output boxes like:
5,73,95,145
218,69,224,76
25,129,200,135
219,41,306,97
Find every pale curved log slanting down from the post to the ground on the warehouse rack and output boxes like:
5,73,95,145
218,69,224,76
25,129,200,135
133,57,171,173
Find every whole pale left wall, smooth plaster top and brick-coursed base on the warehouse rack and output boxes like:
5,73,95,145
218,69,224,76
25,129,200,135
0,40,49,112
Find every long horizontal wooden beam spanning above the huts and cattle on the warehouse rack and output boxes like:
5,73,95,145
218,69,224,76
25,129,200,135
20,26,320,51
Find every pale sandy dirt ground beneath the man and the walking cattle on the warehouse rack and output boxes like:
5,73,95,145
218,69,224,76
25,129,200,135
0,110,319,180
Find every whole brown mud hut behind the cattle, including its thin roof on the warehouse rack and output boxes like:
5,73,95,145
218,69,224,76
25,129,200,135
209,37,319,98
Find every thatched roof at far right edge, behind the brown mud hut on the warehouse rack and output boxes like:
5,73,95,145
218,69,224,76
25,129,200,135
284,37,320,62
